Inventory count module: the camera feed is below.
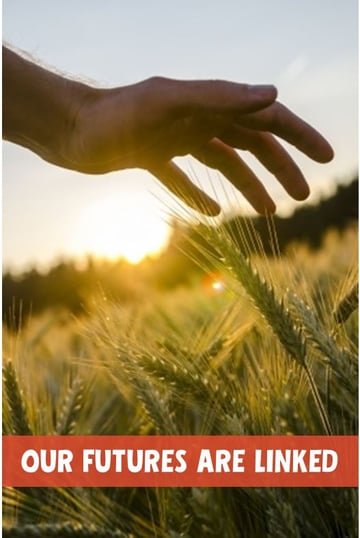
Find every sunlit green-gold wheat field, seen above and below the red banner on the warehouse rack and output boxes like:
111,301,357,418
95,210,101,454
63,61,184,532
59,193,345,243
3,220,357,538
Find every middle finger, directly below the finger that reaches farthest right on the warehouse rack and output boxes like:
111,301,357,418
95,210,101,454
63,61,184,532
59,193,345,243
221,126,310,200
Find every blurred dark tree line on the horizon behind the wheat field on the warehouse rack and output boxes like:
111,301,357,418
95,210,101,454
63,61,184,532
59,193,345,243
2,178,358,328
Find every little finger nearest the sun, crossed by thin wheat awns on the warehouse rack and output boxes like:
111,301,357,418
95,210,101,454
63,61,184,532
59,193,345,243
148,161,220,217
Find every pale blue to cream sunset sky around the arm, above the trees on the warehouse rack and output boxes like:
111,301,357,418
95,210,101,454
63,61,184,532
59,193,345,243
2,0,358,271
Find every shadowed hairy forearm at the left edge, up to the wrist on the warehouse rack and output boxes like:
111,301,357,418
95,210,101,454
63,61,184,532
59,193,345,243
3,47,89,166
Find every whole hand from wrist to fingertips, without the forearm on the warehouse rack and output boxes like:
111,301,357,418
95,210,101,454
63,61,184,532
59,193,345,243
64,77,333,215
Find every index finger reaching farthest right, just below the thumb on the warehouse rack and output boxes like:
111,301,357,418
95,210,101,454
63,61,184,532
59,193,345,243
238,103,334,163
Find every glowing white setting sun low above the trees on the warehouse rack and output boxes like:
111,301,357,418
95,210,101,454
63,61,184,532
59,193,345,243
72,197,169,263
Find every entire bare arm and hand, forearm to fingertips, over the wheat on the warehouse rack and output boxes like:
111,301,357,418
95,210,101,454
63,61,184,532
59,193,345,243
3,47,333,216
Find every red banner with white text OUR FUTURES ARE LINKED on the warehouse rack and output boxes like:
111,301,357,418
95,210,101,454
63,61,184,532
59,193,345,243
3,436,358,487
